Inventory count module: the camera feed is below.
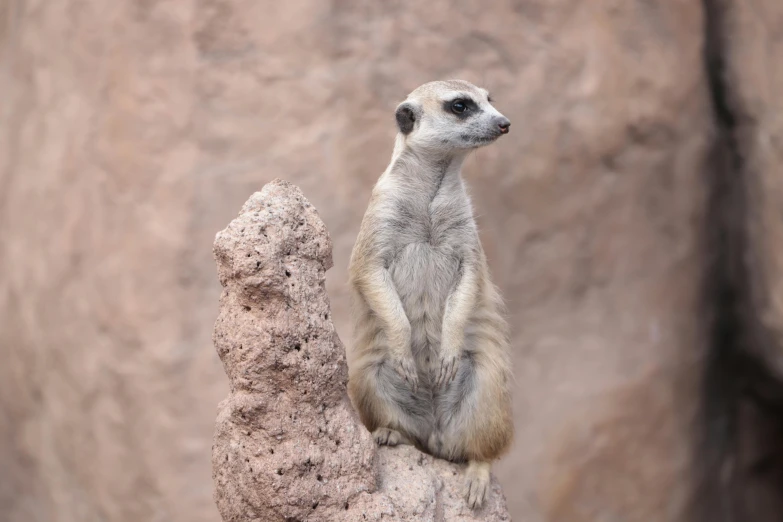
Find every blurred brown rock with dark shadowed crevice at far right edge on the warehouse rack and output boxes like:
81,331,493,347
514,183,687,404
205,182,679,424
704,0,783,522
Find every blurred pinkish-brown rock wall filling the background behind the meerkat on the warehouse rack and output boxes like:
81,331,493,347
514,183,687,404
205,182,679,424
0,0,783,522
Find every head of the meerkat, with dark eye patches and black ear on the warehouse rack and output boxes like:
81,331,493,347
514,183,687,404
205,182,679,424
395,80,511,152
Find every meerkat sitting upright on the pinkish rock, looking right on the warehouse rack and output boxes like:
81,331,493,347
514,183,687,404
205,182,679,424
348,80,513,508
